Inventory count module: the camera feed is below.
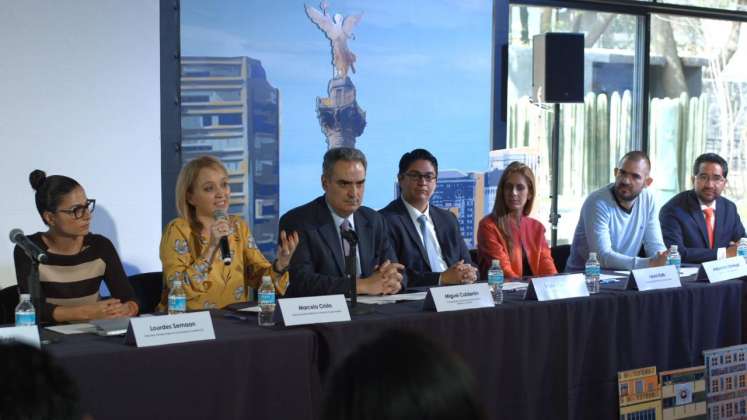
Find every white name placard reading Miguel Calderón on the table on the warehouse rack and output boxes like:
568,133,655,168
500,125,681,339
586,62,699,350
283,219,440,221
423,283,495,312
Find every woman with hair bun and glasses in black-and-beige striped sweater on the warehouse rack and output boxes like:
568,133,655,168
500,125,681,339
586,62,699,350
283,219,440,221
13,169,138,322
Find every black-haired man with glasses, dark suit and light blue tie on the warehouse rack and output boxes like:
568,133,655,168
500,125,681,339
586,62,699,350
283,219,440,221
380,149,477,287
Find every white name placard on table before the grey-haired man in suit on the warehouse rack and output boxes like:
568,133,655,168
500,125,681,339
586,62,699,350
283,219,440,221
278,295,350,327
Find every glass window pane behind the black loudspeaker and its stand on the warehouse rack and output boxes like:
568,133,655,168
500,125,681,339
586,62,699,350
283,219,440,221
507,5,639,244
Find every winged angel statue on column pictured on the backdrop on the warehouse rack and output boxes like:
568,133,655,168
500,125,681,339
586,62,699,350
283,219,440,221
304,0,366,149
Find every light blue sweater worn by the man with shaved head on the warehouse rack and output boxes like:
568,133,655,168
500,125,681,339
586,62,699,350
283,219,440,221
566,184,666,272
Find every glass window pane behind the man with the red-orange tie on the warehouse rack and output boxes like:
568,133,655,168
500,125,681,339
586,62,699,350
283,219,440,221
649,15,747,212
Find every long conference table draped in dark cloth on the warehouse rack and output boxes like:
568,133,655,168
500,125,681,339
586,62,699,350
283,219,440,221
43,280,743,420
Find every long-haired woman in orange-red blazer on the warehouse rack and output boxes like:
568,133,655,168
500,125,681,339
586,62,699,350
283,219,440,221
477,162,558,278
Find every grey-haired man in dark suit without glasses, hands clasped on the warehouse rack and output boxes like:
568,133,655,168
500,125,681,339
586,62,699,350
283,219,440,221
280,147,404,296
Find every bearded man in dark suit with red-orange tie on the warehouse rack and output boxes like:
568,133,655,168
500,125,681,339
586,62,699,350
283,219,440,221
659,153,745,263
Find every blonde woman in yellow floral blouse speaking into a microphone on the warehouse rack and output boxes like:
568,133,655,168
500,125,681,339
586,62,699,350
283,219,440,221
159,156,298,310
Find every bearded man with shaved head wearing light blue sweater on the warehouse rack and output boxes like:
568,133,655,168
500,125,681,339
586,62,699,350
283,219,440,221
566,151,667,272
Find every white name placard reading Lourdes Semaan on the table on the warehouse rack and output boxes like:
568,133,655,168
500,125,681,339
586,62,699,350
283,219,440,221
125,311,215,347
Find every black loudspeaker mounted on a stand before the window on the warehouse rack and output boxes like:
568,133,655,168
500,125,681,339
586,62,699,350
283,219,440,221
532,32,584,103
